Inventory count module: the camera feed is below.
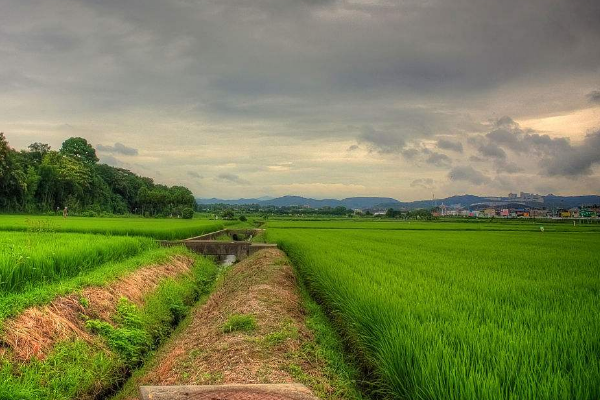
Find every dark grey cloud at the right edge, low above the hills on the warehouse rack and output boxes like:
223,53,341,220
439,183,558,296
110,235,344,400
540,130,600,177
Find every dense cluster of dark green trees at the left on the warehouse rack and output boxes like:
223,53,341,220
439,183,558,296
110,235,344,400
0,133,196,218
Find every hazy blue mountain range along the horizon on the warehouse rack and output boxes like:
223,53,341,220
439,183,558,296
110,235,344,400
196,194,600,210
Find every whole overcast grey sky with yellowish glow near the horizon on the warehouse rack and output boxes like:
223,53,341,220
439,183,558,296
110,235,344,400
0,0,600,201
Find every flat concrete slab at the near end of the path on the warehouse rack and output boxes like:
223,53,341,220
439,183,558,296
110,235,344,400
140,383,318,400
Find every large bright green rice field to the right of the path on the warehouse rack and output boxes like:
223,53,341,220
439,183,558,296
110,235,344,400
267,220,600,399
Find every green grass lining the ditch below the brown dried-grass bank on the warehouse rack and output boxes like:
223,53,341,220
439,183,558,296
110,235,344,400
0,248,217,400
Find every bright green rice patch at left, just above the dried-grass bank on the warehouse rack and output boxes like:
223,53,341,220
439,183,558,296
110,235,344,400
0,232,157,294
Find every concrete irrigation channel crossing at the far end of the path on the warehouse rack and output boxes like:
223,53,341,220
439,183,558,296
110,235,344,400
160,229,277,261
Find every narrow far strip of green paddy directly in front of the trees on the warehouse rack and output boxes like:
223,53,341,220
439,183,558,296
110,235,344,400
0,215,230,240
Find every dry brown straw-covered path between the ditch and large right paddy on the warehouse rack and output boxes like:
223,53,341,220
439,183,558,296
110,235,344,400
115,249,354,399
